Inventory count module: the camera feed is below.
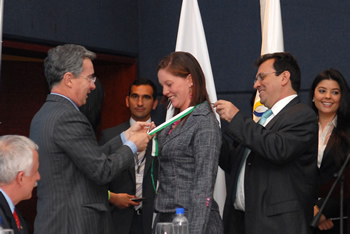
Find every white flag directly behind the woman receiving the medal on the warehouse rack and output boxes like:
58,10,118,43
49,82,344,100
174,0,226,216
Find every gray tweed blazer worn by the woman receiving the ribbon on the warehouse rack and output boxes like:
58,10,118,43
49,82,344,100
155,102,222,234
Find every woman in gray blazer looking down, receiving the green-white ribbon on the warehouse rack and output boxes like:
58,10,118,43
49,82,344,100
154,52,223,234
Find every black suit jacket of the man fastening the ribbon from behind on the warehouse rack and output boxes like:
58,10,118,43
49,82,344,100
220,97,318,234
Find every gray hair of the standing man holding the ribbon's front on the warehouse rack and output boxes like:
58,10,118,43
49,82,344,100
44,44,96,90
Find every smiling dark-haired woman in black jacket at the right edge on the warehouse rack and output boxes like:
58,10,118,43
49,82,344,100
309,69,350,233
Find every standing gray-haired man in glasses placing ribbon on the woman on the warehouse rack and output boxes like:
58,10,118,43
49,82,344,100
30,45,151,234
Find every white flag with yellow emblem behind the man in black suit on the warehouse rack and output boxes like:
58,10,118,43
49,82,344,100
253,0,284,122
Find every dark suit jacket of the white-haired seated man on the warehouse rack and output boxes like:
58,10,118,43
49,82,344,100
0,192,28,234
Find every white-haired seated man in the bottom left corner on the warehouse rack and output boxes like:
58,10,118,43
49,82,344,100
0,135,40,234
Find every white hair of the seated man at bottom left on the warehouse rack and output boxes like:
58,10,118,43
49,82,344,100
0,135,39,184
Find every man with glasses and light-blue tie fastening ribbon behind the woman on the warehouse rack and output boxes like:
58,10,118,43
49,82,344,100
214,53,318,234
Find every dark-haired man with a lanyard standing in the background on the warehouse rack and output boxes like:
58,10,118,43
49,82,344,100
100,79,158,234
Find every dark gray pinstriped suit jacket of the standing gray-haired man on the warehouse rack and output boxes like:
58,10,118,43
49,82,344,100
30,95,134,234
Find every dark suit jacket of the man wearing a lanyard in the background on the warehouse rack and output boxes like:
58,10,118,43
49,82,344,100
100,121,158,234
